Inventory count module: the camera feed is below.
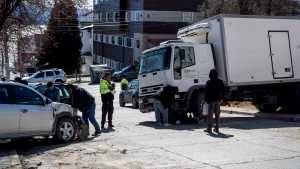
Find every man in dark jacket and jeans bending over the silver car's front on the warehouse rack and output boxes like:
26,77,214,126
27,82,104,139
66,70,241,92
67,85,101,136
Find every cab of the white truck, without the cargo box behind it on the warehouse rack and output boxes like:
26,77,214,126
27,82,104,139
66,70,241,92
139,41,214,113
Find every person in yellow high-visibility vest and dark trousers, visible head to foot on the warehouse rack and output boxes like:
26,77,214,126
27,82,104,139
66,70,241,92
100,73,115,129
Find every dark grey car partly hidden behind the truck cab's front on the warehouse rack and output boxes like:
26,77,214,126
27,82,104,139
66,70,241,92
119,79,139,108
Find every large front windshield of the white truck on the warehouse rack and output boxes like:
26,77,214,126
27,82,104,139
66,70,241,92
140,47,172,74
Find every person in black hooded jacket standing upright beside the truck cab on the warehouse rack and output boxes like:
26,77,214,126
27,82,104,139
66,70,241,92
205,69,225,133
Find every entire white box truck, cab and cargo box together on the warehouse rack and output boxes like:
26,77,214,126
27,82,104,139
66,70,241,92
139,15,300,118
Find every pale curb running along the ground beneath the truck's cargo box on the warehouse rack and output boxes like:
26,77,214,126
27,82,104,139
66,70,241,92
221,110,300,123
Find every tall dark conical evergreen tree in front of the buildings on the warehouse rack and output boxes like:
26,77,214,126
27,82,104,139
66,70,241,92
38,0,82,74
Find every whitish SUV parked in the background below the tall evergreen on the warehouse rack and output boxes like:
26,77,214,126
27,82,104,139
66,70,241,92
22,69,67,83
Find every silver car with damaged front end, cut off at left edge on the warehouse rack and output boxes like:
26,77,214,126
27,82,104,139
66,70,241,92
0,82,77,142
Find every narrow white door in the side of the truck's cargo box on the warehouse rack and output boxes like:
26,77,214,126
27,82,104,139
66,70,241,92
269,31,294,79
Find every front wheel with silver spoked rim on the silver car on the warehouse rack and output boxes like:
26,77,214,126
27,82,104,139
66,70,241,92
55,118,76,143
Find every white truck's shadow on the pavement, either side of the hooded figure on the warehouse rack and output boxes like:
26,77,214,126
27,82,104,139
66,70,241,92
138,117,300,131
